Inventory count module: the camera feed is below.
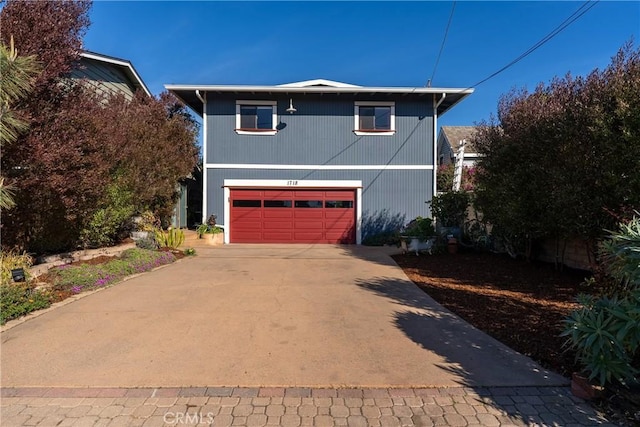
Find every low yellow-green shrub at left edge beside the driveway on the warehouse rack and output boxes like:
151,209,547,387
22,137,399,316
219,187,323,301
0,282,51,325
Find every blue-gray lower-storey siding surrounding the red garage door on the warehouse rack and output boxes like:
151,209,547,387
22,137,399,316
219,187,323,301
205,169,433,238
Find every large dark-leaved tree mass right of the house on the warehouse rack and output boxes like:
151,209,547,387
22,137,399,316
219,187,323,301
475,43,640,256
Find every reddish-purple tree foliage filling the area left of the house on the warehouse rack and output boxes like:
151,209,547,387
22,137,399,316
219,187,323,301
0,1,197,253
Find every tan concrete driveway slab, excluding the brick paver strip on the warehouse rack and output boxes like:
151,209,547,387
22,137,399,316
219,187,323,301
1,245,567,387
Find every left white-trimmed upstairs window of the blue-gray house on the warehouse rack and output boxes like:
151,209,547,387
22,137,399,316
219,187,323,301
235,101,278,135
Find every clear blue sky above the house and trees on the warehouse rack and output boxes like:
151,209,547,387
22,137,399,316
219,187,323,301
84,1,640,130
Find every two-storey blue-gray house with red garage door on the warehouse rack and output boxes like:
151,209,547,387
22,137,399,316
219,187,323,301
165,80,473,244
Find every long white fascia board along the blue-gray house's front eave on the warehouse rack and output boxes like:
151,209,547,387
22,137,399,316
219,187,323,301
164,85,474,94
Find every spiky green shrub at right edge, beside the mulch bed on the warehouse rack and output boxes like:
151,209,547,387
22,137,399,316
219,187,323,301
561,217,640,385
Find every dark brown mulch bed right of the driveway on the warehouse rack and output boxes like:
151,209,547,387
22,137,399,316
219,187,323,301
393,252,640,425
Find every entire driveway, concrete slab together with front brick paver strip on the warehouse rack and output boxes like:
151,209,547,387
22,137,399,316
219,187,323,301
0,245,616,426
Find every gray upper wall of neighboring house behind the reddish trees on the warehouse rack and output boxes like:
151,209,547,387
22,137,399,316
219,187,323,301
71,58,135,100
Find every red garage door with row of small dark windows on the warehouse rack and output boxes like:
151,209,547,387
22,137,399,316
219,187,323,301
230,189,356,243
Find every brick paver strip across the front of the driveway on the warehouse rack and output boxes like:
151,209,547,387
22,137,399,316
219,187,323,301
0,387,613,427
